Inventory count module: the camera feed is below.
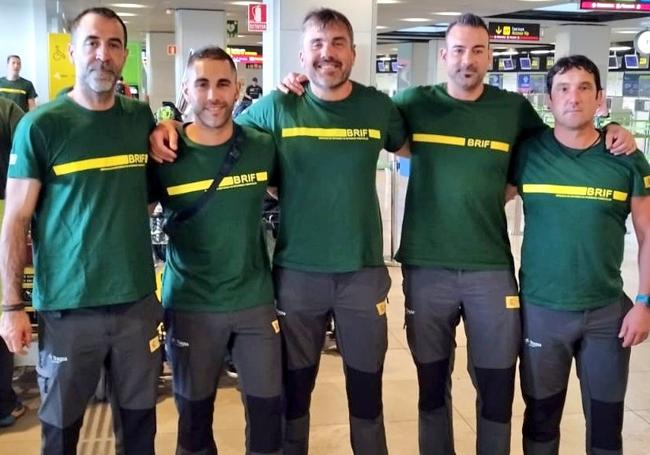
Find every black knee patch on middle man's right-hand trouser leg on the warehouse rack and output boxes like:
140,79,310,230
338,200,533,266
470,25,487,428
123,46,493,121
345,365,383,420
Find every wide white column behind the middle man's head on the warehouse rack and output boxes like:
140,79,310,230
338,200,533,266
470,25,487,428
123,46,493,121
263,0,377,93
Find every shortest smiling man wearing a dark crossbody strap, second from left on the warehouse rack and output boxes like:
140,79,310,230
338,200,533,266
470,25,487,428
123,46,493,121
151,47,282,454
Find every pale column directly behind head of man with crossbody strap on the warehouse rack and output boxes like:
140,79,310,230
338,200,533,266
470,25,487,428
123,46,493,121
175,9,227,98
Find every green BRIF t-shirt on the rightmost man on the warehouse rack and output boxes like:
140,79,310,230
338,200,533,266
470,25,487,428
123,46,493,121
513,129,650,311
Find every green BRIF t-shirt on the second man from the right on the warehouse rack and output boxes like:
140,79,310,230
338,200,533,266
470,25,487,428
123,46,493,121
393,84,544,270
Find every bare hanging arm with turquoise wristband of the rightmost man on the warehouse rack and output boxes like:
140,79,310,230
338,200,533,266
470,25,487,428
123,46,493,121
618,196,650,348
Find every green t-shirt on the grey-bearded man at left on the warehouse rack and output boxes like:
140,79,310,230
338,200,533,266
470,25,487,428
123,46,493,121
9,96,155,310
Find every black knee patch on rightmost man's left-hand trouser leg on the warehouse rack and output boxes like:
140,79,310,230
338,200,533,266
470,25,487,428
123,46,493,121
523,389,566,442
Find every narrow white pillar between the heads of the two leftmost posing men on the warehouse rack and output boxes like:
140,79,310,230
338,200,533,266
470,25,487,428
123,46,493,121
146,32,176,112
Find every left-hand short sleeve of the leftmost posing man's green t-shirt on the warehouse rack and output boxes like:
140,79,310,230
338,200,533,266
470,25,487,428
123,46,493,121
7,117,49,181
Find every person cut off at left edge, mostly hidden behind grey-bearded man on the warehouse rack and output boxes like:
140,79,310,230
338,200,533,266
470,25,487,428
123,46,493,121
0,98,25,427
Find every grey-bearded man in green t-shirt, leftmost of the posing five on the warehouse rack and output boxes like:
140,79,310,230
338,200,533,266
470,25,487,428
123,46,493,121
0,8,162,455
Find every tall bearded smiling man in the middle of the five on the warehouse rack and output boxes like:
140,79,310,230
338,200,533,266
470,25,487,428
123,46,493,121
152,8,406,455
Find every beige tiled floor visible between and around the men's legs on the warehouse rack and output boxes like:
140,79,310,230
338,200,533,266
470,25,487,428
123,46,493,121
0,205,650,455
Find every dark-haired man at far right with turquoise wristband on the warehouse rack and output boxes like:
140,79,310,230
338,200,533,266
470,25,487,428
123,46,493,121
512,55,650,455
